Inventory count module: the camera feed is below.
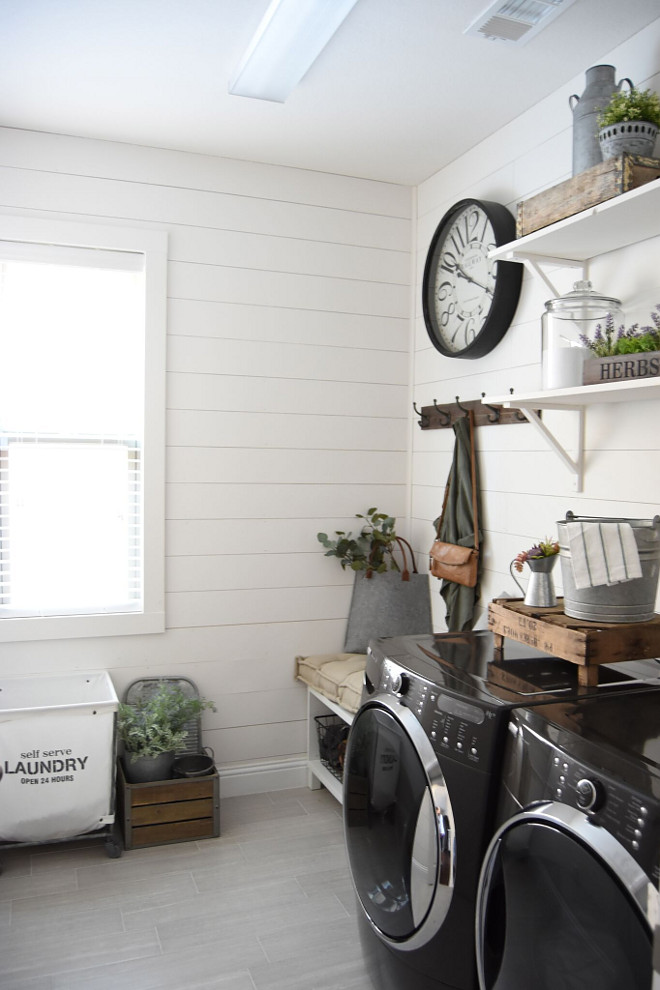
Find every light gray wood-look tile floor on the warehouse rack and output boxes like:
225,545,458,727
0,788,372,990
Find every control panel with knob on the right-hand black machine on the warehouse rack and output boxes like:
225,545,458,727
548,754,660,886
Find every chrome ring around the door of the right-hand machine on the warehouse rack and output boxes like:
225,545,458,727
475,801,660,990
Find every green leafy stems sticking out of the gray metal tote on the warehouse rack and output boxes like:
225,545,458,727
316,507,400,577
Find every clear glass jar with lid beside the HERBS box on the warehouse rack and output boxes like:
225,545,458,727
541,280,624,389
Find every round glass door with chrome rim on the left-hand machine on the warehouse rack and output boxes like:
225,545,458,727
344,696,456,950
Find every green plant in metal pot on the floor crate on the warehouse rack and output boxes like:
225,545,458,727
117,681,214,783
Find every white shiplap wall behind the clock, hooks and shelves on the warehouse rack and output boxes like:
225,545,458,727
412,20,660,629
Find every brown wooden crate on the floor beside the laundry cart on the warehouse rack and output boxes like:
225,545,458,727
117,760,220,849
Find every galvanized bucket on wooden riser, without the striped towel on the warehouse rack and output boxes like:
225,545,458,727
557,512,660,622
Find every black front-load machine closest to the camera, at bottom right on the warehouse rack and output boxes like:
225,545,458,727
477,691,660,990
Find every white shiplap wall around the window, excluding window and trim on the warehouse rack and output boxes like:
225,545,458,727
0,128,412,794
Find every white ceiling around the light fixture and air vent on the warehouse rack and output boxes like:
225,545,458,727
0,0,660,185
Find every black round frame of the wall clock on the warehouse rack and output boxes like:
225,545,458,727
422,198,523,359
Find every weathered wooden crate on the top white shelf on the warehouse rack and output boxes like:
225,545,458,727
516,155,660,237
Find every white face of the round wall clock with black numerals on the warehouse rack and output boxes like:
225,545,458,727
433,205,497,354
